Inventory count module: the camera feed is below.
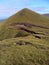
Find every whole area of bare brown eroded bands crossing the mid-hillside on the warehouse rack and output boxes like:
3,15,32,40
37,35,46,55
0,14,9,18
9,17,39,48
9,22,49,39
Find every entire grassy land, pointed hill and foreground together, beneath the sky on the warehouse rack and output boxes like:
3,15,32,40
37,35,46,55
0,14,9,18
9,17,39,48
0,8,49,65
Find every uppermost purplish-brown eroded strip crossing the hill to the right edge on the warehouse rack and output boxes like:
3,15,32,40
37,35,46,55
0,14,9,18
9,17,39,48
11,23,49,29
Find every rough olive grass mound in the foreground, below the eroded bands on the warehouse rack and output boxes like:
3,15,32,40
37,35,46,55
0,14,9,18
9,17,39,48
0,36,49,65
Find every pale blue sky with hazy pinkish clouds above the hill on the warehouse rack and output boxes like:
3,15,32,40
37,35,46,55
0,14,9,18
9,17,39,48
0,0,49,18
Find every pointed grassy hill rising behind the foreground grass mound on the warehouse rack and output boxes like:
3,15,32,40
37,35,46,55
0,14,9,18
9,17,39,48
0,8,49,39
